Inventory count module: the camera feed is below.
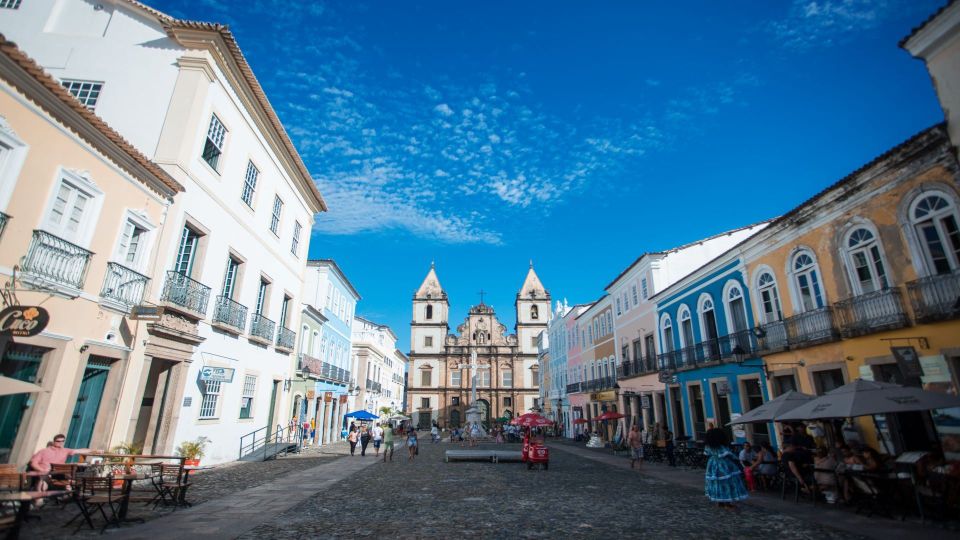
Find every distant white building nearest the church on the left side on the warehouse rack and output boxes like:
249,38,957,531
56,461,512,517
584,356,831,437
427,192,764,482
353,316,407,416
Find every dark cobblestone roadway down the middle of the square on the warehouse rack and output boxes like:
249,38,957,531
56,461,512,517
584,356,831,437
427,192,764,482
241,443,857,540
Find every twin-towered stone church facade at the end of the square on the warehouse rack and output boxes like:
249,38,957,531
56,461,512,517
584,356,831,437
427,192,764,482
406,264,550,429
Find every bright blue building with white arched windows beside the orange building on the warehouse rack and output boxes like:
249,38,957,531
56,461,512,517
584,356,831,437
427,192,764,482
652,258,773,443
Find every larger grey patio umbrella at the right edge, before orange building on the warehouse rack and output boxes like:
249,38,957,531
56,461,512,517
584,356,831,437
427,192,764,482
777,379,960,422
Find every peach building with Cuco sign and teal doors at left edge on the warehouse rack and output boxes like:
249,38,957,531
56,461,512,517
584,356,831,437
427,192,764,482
0,40,183,465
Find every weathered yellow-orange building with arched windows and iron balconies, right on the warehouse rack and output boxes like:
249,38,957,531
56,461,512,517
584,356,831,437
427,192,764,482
741,125,960,451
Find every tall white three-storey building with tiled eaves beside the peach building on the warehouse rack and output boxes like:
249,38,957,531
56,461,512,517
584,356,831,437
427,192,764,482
0,0,326,463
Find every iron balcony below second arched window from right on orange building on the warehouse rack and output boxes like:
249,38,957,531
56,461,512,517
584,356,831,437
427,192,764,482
833,289,910,337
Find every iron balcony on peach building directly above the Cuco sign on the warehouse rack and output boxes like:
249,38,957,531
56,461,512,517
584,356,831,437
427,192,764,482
20,230,93,295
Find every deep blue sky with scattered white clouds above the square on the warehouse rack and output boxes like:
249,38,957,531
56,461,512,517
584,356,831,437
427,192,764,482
151,0,943,351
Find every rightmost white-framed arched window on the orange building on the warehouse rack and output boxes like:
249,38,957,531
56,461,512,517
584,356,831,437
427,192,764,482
910,192,960,275
